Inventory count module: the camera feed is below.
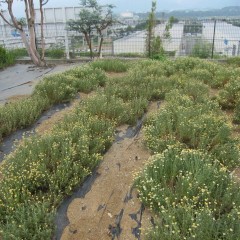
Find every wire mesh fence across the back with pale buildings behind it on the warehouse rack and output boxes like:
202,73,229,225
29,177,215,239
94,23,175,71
0,19,240,58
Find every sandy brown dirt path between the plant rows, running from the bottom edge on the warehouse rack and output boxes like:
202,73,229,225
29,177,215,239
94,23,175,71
61,126,150,240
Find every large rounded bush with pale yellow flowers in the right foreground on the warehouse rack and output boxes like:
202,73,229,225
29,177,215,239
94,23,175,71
136,146,240,240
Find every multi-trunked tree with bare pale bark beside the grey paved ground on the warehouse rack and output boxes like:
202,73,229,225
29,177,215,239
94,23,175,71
0,0,49,66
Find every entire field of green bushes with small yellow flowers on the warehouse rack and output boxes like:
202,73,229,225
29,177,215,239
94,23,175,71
0,58,240,240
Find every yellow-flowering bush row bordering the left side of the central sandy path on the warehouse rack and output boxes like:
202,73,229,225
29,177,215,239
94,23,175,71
0,110,114,240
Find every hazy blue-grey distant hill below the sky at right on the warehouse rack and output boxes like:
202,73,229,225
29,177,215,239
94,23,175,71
137,6,240,18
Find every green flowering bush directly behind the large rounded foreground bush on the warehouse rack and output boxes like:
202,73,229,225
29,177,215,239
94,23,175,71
145,91,240,168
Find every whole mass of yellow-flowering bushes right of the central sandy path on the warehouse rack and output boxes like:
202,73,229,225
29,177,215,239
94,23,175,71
135,58,240,240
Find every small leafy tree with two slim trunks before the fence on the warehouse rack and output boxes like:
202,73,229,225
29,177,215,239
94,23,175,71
68,0,114,58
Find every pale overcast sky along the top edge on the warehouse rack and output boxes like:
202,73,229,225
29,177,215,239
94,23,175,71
7,0,240,15
